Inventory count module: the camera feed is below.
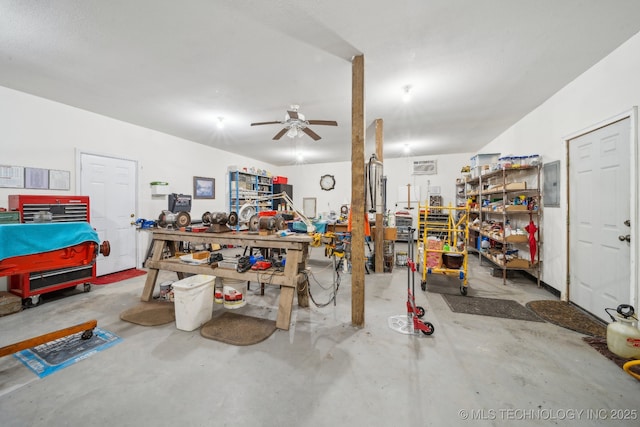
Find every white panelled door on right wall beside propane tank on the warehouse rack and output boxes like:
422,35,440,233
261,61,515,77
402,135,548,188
569,118,632,320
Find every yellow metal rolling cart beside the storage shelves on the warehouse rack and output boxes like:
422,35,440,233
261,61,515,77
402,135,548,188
419,205,469,295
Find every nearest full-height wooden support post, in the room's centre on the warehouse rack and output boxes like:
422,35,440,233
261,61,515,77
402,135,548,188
351,55,366,327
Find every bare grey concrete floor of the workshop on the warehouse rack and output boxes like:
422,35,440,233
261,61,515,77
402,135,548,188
0,244,640,427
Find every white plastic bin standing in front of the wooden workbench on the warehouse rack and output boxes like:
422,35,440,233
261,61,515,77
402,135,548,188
173,274,216,331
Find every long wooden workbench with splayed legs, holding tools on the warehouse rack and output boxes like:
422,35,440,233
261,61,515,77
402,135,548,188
141,229,312,330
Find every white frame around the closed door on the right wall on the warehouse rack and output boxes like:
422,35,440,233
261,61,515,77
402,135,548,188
561,106,640,309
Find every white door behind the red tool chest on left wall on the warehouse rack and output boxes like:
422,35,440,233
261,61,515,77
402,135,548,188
80,153,137,276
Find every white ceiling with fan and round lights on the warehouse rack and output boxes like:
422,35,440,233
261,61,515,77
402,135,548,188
0,0,640,165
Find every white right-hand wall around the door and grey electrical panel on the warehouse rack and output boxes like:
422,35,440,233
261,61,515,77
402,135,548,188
482,33,640,295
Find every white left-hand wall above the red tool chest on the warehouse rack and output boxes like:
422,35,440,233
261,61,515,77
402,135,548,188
0,87,274,289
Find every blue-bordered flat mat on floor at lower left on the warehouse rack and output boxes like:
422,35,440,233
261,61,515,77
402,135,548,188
14,327,122,378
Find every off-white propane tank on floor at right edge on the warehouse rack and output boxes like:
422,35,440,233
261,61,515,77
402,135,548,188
605,304,640,359
